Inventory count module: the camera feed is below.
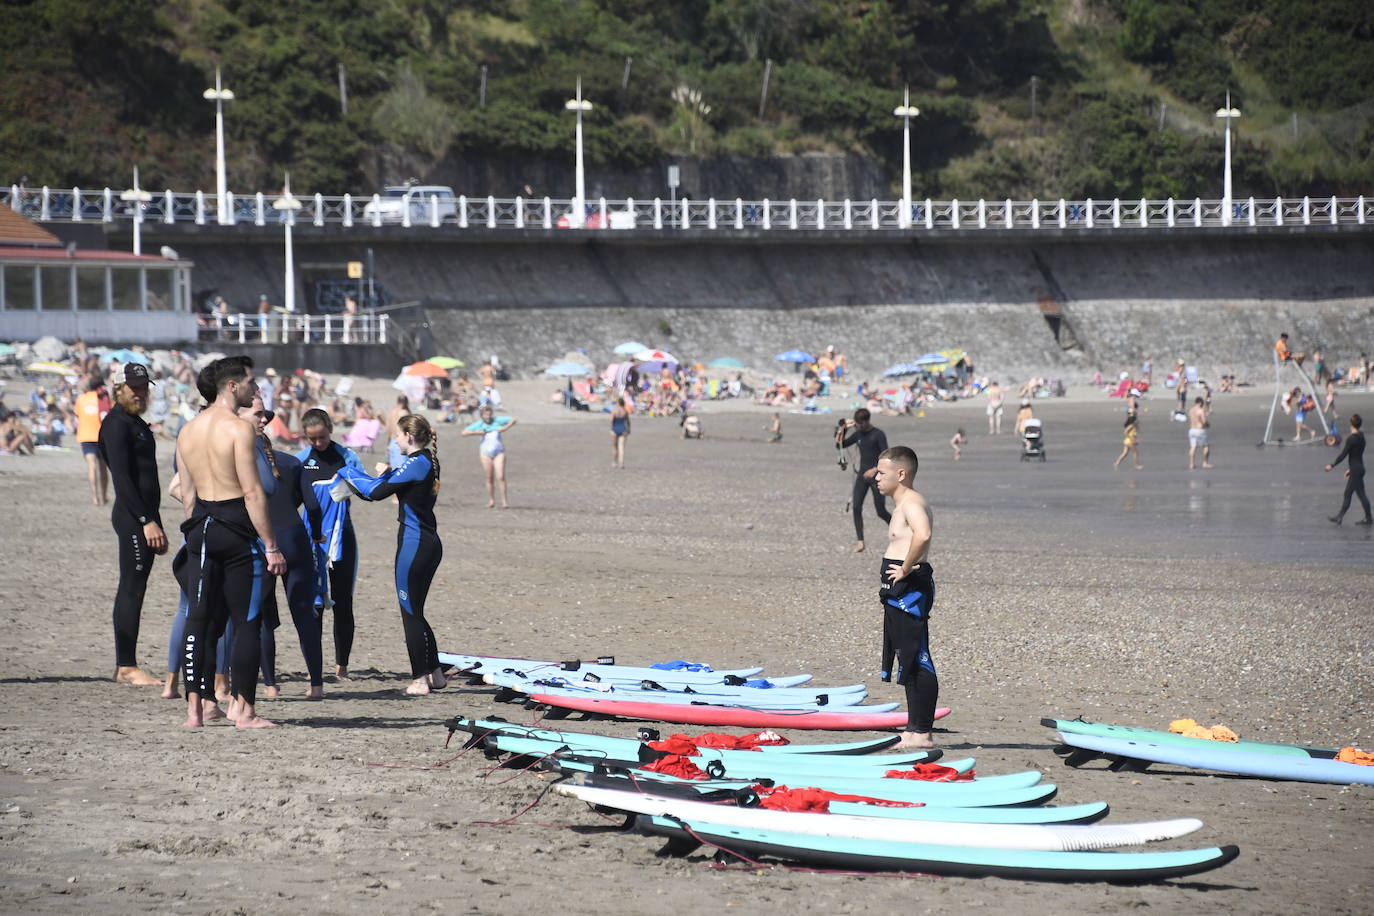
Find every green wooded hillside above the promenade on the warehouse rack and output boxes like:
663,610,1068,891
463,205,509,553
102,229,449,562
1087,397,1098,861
0,0,1374,198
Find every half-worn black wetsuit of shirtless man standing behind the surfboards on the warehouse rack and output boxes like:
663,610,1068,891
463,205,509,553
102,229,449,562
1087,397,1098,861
878,556,940,732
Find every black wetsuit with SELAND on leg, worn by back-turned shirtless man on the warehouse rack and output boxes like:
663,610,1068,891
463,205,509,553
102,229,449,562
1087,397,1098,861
181,496,268,703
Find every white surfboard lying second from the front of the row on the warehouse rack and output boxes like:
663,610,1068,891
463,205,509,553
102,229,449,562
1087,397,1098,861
554,783,1202,851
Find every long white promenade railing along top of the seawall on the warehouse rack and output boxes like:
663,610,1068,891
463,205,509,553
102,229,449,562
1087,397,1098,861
0,185,1374,232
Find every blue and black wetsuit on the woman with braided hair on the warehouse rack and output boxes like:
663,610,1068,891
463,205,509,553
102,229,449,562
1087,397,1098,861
339,452,444,677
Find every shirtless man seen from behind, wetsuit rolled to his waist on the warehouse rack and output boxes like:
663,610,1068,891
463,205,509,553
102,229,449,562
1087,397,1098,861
176,356,286,728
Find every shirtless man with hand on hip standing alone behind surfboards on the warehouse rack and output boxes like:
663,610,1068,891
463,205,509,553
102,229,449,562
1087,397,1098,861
877,445,940,750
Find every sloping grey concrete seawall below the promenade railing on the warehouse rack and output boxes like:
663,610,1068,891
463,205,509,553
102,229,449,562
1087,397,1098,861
120,227,1374,379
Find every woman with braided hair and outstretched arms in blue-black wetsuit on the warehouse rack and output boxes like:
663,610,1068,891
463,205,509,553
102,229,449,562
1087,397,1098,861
328,413,447,695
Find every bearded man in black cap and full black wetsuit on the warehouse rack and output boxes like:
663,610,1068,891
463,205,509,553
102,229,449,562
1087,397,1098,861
98,363,168,687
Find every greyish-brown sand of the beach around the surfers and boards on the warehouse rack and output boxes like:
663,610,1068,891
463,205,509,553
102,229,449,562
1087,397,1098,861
0,383,1374,913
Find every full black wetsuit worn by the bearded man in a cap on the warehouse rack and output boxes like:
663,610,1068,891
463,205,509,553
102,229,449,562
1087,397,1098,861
99,405,162,667
